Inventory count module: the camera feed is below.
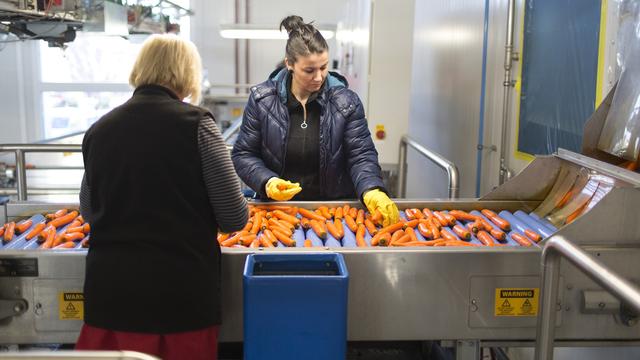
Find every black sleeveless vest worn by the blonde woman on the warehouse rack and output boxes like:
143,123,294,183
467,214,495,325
82,86,220,333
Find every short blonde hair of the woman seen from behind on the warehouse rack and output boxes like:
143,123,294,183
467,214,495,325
129,35,202,104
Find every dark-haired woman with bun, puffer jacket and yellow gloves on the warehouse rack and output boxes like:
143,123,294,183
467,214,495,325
232,15,399,226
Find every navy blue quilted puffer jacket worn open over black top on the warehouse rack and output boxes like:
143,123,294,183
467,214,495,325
232,69,385,200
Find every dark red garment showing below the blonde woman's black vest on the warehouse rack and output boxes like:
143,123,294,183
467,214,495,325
75,324,219,360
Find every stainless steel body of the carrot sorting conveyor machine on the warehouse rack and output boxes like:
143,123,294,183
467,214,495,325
0,88,640,359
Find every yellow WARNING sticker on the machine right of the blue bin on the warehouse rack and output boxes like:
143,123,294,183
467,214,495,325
495,288,540,316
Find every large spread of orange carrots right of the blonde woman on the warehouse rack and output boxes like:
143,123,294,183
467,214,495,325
218,205,542,248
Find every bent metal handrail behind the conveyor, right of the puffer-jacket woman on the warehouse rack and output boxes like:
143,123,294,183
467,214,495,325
398,135,460,199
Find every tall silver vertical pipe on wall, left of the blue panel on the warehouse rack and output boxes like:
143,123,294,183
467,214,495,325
499,0,516,184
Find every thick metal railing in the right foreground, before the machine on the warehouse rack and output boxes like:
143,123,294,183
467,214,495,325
534,236,640,360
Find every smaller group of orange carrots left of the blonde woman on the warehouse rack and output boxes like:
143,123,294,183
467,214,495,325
0,209,91,249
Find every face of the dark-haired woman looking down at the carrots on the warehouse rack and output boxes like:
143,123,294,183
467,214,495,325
285,51,329,93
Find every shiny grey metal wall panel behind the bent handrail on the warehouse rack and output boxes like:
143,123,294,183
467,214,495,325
407,0,485,198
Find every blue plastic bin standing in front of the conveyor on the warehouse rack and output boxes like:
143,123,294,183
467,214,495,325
243,253,349,360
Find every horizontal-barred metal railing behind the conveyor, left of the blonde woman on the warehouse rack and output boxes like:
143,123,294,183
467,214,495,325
0,144,233,201
